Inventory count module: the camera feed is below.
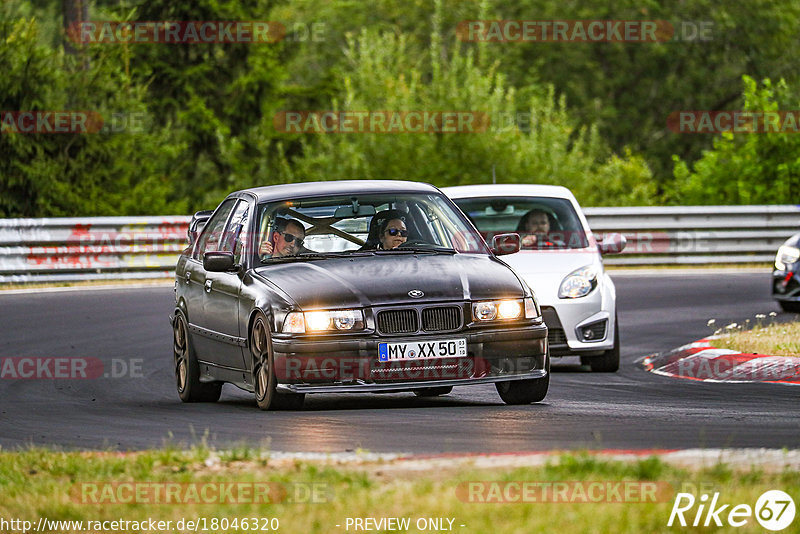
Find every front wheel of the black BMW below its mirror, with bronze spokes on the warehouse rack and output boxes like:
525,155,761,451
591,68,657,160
250,313,305,410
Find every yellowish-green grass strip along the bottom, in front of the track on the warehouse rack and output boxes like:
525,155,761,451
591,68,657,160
0,446,800,534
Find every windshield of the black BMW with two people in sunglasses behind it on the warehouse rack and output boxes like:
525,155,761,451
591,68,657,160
257,193,489,263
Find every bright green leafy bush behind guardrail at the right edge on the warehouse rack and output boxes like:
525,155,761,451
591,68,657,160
671,76,800,204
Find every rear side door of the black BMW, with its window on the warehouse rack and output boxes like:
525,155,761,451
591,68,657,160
183,199,237,361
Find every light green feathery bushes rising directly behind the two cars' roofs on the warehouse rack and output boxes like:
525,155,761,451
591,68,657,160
282,29,653,208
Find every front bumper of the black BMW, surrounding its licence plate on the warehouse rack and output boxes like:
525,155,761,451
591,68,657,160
272,324,548,393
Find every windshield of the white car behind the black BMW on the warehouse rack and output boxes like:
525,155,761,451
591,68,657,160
454,197,589,249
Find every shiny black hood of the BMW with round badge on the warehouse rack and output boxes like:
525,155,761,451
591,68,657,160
256,254,524,309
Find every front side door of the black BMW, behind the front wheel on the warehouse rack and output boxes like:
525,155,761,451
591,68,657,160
203,200,252,369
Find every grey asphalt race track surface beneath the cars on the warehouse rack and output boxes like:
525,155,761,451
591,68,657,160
0,270,800,453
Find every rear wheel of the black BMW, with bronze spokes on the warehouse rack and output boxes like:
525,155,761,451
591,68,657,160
172,313,222,402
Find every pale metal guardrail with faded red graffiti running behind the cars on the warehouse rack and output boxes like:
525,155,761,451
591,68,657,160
0,205,800,283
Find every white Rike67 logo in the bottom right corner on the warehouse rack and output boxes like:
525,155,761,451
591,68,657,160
667,490,795,532
